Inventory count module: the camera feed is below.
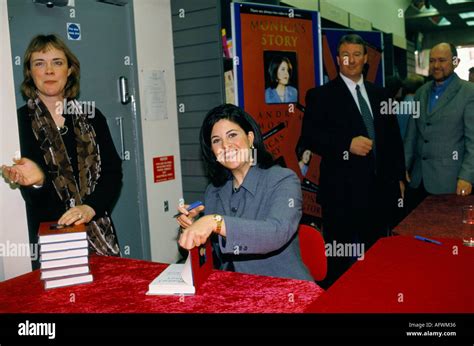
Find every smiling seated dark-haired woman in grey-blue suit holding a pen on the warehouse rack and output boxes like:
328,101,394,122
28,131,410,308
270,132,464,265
174,104,313,280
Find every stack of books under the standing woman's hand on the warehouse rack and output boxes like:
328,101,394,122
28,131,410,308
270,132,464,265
38,222,93,289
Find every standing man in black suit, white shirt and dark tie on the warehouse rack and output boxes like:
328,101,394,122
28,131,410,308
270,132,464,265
302,34,405,286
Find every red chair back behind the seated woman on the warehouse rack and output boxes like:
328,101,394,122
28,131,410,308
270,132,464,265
298,225,328,281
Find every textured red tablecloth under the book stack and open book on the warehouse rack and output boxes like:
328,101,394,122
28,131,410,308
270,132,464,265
0,256,324,313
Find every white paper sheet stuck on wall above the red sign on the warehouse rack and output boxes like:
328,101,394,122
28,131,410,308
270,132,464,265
142,70,168,121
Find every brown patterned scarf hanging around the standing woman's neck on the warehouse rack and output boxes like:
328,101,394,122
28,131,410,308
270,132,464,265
28,98,120,256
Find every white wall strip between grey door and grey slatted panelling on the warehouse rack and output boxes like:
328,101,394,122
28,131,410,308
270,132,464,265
133,0,183,263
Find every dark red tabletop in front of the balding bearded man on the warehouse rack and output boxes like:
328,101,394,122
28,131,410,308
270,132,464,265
393,195,474,239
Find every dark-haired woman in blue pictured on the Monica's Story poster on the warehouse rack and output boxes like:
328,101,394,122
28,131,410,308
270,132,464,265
265,56,298,103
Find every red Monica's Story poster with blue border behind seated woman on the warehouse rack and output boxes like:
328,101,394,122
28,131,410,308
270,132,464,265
232,4,323,225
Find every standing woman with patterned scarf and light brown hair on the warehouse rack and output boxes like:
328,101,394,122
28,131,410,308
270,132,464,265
2,35,122,268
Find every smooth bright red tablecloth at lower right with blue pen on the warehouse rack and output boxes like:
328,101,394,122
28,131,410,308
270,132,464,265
307,236,474,313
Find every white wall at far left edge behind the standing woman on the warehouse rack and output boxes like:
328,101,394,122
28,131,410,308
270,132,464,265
0,0,31,281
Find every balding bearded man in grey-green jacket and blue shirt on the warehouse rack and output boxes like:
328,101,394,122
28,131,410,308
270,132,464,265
404,43,474,209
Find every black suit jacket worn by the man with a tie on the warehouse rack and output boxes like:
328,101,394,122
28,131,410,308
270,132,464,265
301,76,405,207
